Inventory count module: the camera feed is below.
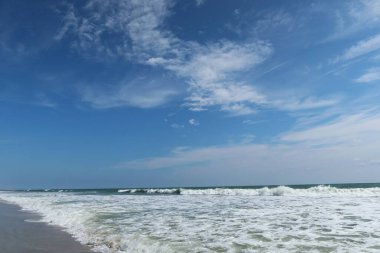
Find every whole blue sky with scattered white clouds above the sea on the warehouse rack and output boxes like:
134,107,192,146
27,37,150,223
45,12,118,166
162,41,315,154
0,0,380,189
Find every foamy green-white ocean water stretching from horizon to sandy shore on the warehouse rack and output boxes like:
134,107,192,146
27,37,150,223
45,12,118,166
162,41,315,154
0,184,380,253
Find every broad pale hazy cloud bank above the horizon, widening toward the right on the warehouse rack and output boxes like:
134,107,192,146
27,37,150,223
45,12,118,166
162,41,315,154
118,111,380,184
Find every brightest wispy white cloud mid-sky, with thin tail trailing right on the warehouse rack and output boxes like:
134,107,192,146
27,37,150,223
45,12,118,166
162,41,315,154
148,41,340,116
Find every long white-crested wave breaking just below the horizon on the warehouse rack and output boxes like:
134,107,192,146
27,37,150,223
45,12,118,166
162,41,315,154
117,185,380,197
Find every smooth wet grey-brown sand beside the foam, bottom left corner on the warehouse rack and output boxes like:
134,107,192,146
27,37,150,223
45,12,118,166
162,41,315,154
0,200,93,253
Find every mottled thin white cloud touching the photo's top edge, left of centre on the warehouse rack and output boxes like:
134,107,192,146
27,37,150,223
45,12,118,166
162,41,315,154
55,0,176,61
